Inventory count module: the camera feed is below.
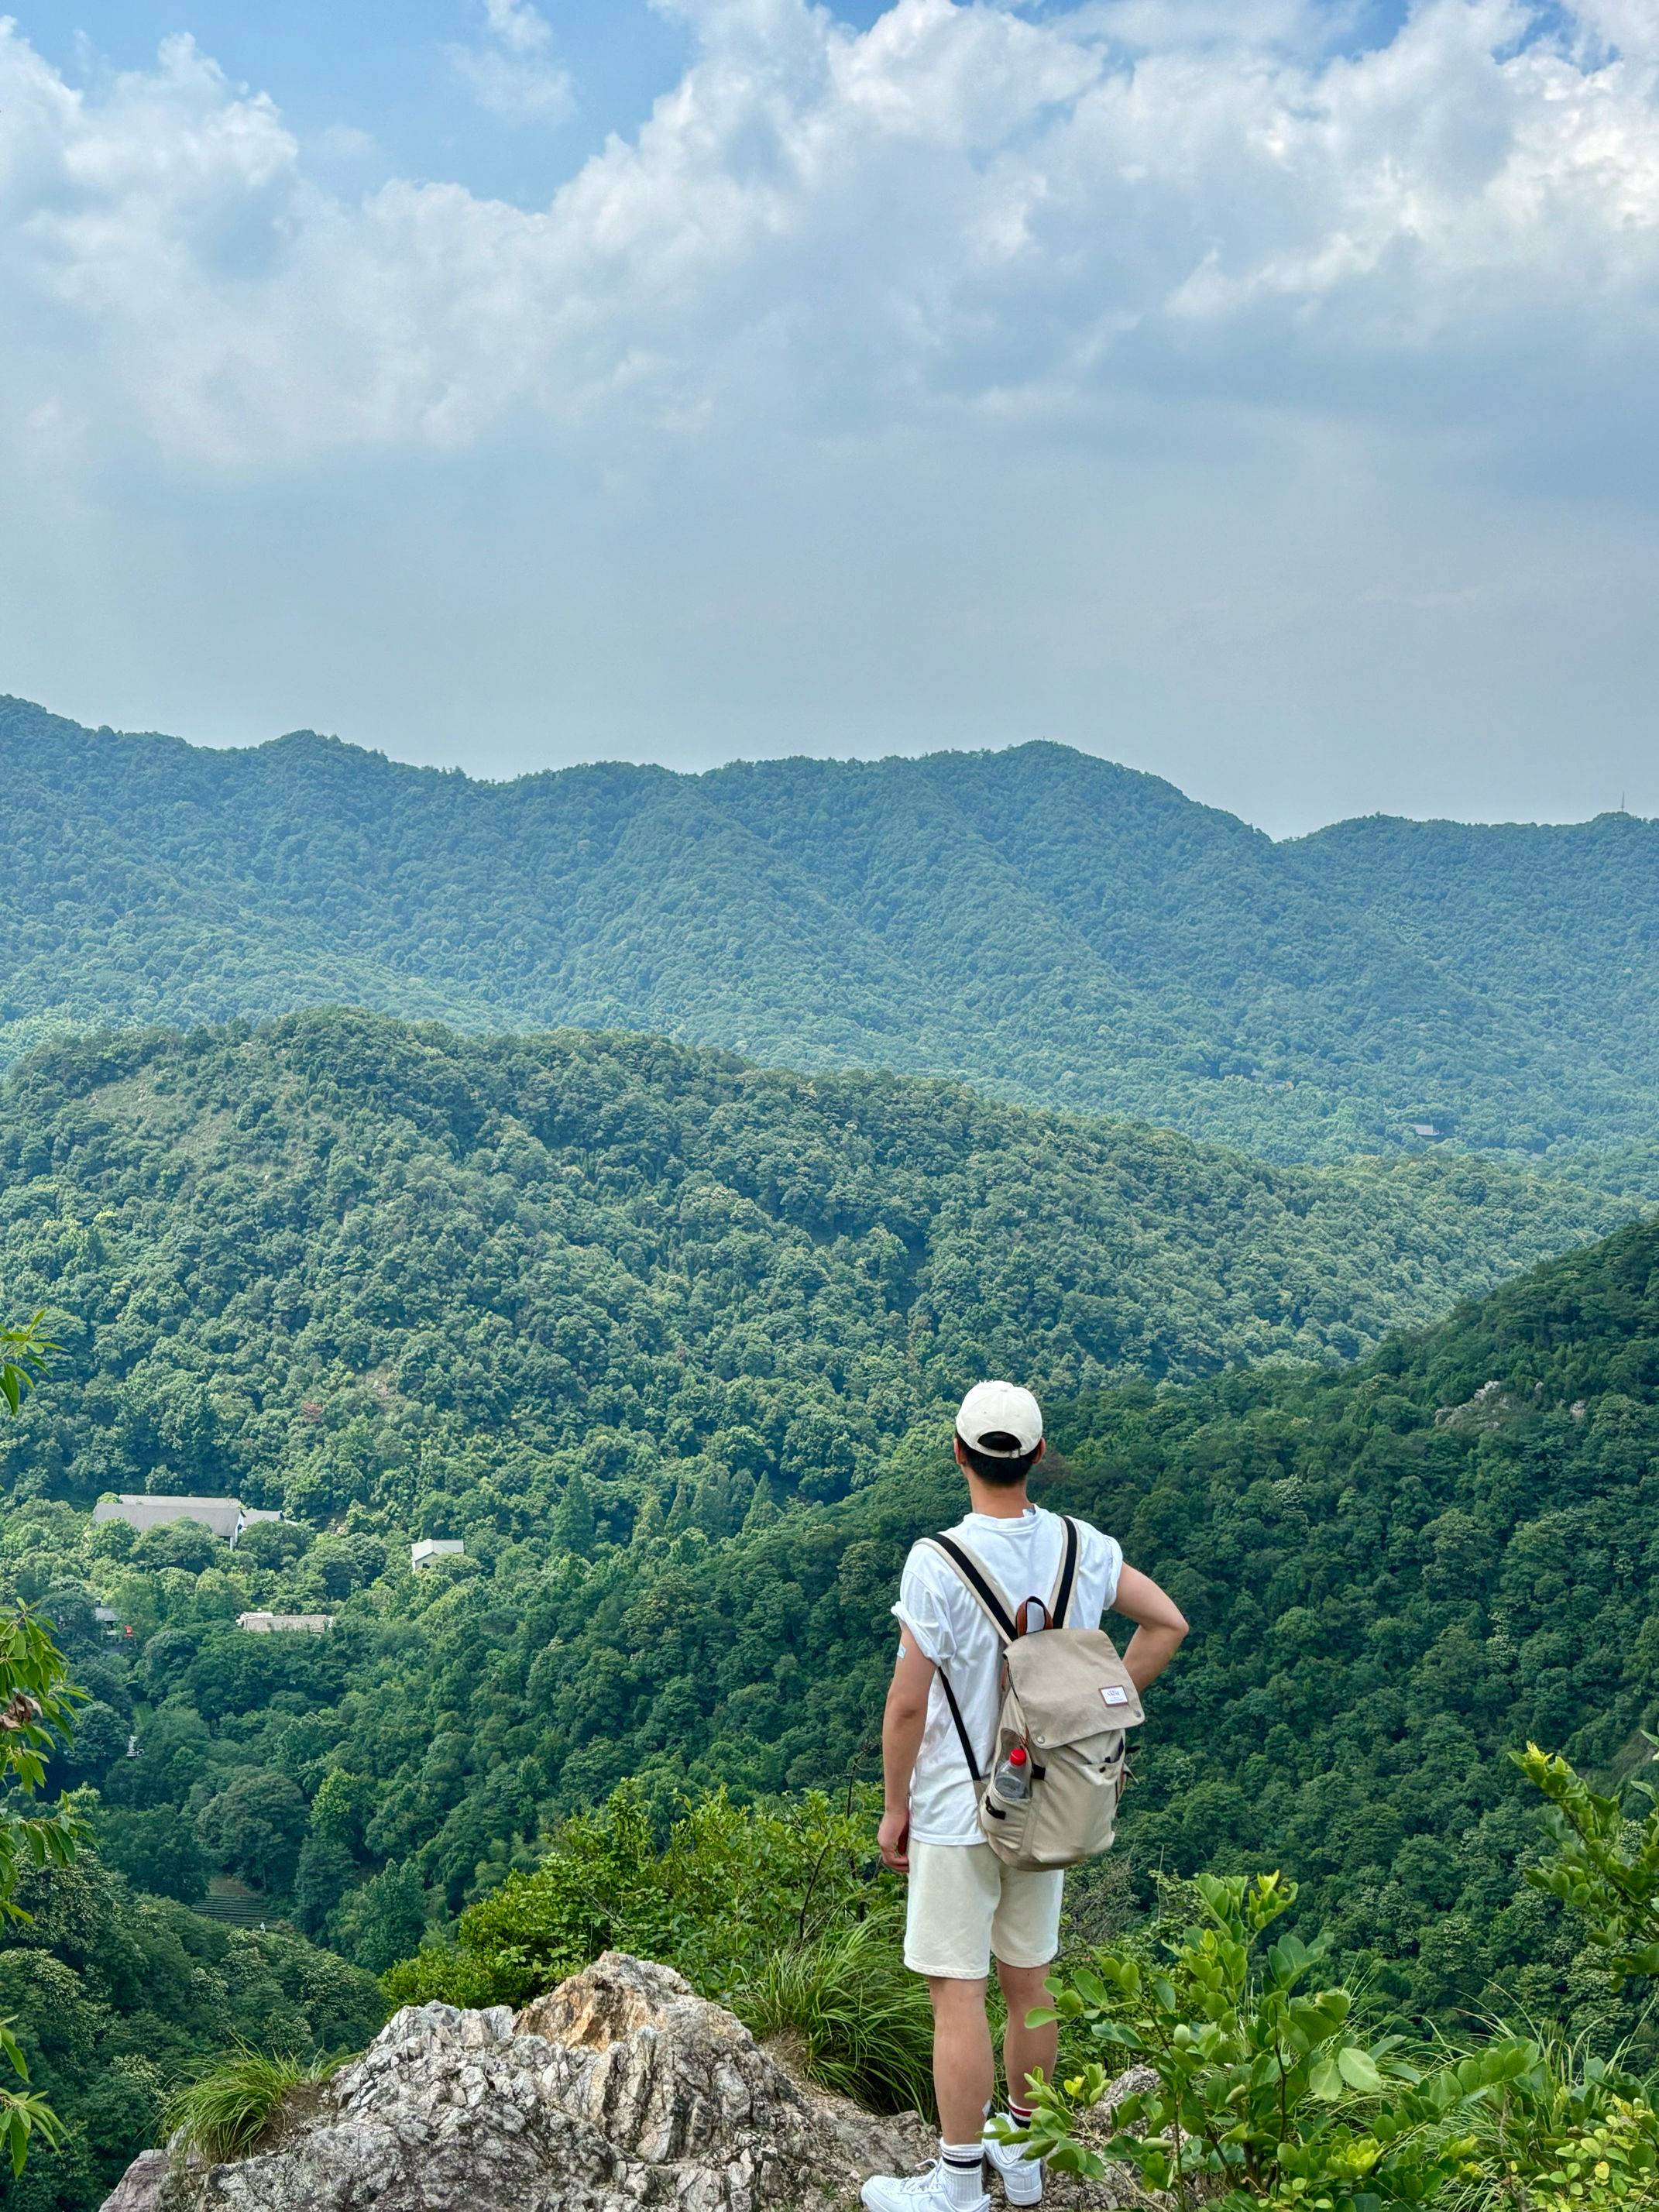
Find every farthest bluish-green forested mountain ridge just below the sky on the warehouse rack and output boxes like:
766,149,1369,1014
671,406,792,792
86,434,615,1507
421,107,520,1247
0,701,1659,1192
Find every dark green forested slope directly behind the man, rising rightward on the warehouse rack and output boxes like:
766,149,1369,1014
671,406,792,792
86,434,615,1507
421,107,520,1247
305,1225,1659,2013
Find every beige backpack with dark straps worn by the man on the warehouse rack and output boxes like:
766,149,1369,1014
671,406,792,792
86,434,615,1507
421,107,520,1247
925,1515,1146,1871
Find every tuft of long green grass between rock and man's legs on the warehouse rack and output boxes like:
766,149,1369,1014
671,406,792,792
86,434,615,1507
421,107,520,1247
747,1920,933,2112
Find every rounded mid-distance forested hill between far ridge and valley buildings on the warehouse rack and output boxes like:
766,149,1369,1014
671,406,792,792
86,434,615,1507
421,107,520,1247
0,1013,1626,1542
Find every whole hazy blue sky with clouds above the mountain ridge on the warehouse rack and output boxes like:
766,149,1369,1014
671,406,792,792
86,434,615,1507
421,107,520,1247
0,0,1659,832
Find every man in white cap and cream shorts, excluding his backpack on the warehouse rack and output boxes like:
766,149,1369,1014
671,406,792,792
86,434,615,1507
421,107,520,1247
863,1382,1186,2212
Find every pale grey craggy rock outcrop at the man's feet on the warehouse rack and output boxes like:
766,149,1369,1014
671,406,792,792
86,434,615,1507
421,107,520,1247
94,1951,1159,2212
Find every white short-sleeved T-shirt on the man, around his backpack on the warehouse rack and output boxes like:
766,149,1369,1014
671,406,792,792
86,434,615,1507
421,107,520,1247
894,1506,1124,1843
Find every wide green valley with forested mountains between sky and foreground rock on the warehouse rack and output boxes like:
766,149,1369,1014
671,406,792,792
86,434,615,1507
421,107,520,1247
0,747,1659,2212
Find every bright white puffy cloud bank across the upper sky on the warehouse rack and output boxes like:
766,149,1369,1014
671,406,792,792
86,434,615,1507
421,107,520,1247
0,0,1659,465
